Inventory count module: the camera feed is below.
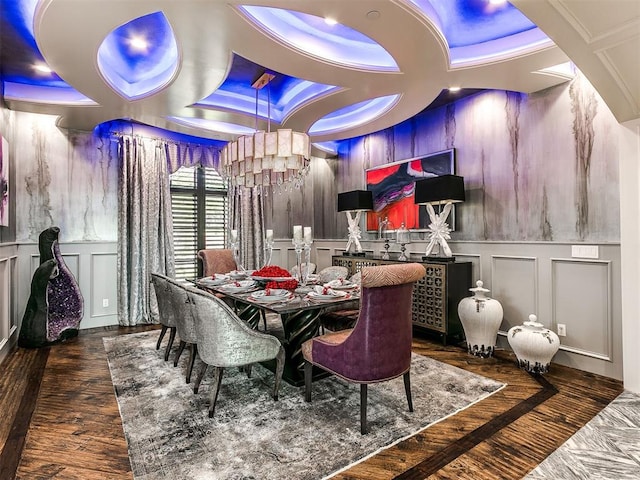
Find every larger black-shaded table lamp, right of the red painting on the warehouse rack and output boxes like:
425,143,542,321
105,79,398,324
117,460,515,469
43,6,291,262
414,175,465,262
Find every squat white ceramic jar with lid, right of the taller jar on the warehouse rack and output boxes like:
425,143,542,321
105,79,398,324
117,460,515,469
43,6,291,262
507,315,560,374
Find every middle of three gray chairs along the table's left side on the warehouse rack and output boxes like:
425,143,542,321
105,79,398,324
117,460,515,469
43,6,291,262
164,277,198,383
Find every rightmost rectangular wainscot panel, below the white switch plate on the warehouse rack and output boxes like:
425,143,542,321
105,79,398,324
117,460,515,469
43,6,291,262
551,258,612,360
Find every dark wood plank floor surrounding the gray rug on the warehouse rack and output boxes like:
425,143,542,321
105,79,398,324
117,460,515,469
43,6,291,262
0,327,623,480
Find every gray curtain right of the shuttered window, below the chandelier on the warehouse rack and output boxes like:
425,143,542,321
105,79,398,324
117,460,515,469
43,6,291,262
229,187,264,269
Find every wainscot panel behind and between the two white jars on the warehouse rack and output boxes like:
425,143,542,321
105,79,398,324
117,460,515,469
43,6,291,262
491,255,539,332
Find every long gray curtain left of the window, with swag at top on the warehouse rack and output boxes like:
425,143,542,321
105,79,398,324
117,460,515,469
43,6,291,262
118,136,218,326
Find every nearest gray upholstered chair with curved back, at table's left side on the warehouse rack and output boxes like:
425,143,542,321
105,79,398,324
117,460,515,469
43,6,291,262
188,288,284,417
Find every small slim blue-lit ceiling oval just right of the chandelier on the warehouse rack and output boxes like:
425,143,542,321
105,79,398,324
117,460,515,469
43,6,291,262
309,95,400,135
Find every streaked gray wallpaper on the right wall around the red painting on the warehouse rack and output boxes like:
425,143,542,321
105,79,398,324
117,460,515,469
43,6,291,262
266,70,620,242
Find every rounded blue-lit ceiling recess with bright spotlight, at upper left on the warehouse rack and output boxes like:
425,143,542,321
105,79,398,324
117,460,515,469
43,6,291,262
98,12,178,100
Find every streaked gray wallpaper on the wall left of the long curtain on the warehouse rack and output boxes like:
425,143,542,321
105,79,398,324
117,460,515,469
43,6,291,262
14,112,118,242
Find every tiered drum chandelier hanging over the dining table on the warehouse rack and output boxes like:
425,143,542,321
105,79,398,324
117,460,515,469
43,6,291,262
220,72,311,188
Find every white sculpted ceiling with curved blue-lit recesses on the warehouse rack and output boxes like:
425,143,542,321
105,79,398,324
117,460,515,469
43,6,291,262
0,0,640,151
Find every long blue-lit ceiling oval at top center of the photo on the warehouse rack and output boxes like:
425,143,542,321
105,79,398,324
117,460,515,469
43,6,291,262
238,5,400,72
